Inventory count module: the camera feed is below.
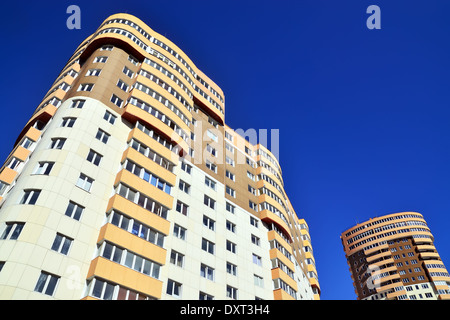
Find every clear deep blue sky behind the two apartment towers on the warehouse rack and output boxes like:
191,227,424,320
0,0,450,300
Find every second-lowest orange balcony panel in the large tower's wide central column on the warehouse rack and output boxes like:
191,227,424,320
98,223,167,265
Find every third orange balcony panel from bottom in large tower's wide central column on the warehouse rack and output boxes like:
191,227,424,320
107,194,170,235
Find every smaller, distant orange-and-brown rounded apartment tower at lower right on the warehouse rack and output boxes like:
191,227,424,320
341,212,450,300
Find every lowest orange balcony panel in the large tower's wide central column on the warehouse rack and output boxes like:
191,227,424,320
87,257,163,299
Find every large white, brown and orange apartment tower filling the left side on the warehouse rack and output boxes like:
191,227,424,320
0,14,320,300
